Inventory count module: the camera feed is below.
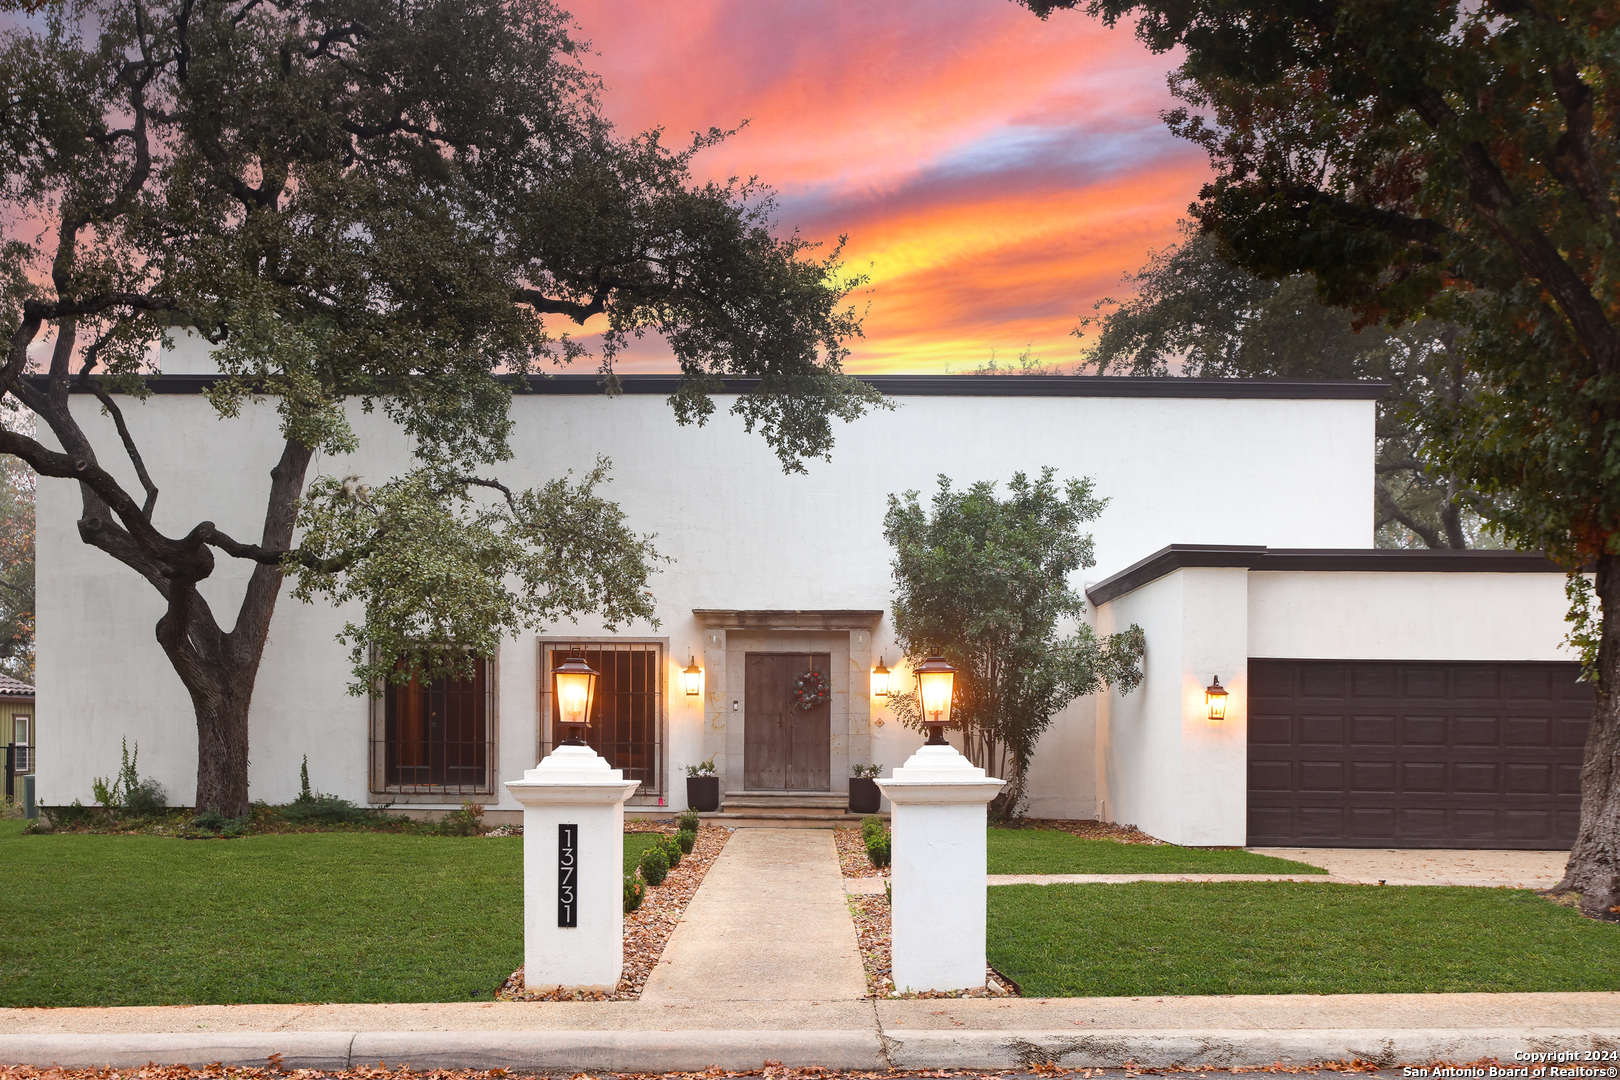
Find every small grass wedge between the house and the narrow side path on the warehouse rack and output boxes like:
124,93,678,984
990,829,1327,874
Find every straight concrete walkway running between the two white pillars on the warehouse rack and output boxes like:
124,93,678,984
642,829,867,1006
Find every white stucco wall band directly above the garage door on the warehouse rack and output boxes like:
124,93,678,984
1249,570,1575,661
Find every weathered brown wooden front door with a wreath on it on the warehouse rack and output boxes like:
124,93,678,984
742,653,833,792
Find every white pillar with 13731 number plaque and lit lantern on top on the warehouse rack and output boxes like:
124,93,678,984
505,657,642,991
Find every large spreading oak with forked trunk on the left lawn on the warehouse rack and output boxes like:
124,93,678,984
0,0,876,816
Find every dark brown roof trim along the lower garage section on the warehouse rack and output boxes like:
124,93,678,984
1085,544,1565,606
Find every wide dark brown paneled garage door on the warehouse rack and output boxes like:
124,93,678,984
1249,659,1592,850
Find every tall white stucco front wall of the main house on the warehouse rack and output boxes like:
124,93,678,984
37,380,1372,809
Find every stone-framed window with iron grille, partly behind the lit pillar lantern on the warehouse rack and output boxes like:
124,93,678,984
539,641,666,801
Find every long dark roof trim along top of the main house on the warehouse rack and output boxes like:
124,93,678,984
24,376,1390,402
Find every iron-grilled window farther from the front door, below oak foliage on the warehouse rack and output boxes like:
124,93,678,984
371,661,496,795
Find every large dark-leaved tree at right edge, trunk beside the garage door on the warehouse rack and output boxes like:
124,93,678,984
1024,0,1620,918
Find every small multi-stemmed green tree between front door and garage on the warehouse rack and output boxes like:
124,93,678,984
883,468,1144,821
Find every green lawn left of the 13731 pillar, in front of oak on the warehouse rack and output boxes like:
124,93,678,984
0,821,523,1006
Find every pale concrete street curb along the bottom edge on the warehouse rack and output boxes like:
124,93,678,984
0,1028,1620,1074
